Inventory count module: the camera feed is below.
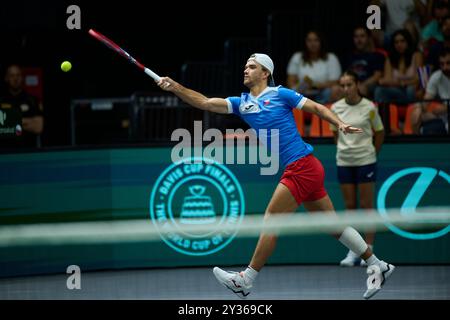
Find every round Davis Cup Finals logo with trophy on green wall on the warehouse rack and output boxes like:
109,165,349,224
150,158,245,256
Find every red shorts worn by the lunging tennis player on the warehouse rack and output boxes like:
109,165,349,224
280,154,327,205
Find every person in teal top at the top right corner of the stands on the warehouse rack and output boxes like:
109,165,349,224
421,0,450,48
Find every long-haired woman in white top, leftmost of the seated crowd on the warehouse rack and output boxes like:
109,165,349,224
287,31,341,104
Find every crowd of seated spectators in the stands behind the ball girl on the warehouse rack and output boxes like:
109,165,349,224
286,0,450,134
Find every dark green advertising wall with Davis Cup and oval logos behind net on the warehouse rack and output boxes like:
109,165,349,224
0,143,450,276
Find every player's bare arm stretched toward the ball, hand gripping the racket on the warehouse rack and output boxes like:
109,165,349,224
158,77,228,113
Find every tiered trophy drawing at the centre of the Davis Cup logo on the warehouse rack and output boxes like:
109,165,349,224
180,185,216,224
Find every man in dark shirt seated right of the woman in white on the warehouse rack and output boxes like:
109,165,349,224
345,26,385,97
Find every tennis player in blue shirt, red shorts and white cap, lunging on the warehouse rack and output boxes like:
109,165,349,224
158,53,394,299
